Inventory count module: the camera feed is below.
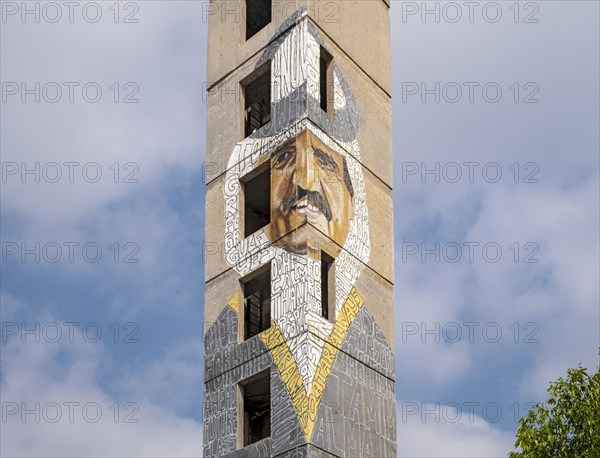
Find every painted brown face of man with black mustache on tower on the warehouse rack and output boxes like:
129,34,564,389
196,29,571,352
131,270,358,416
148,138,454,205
270,132,354,254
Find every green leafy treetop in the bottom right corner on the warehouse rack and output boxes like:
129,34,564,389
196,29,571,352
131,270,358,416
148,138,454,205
509,358,600,458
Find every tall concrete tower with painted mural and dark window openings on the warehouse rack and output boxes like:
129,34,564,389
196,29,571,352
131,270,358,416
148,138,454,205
204,0,396,457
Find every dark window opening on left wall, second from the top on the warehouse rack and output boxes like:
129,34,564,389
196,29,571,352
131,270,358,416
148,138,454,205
242,62,271,137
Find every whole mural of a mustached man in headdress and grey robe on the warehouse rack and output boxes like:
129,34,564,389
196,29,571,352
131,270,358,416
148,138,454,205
204,9,396,457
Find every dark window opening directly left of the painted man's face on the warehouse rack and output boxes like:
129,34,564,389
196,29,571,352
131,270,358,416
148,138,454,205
242,163,271,237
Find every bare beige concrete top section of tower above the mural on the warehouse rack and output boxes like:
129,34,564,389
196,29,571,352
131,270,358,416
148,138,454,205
205,0,392,94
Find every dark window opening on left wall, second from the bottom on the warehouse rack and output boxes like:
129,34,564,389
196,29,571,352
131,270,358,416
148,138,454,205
244,265,271,340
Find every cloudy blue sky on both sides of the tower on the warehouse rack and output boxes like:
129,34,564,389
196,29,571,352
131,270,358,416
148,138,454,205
0,1,600,456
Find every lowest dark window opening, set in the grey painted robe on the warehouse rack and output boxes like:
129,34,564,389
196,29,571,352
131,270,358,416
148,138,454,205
239,369,271,447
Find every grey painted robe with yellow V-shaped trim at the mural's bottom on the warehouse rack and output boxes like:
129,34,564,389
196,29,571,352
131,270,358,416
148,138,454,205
204,296,396,458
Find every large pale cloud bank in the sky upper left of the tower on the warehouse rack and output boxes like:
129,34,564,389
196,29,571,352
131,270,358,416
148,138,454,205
2,2,206,227
